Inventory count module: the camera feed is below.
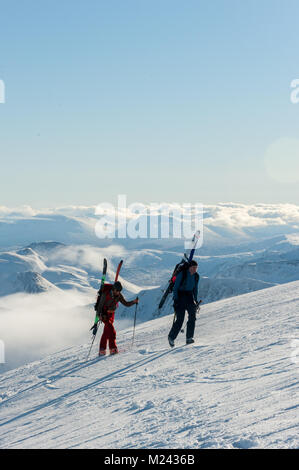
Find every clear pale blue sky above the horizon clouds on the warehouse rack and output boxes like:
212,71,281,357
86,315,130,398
0,0,299,207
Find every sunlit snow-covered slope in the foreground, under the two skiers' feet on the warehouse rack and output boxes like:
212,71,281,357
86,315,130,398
0,281,299,449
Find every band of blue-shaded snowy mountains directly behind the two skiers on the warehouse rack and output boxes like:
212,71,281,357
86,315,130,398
0,230,299,302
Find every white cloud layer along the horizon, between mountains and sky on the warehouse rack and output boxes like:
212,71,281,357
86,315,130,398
0,203,299,252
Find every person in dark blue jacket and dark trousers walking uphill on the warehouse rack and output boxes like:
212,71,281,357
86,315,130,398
168,260,199,347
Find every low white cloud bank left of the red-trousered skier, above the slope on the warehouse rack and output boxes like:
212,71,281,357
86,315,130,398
0,290,132,373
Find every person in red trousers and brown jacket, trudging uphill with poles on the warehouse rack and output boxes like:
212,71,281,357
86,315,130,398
94,281,138,356
